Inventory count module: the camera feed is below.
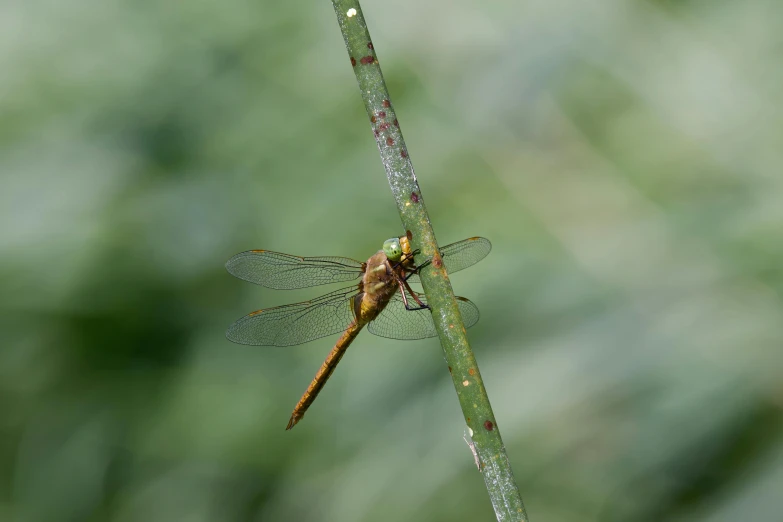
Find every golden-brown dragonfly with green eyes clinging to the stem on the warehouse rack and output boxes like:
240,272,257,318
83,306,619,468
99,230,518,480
226,236,492,430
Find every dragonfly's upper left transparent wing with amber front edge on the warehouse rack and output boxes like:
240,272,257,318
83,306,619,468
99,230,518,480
226,250,364,290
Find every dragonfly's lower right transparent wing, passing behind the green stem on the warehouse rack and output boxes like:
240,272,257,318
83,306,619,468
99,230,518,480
367,292,479,341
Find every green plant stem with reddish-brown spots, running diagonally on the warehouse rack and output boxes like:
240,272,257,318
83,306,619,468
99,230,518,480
332,0,527,521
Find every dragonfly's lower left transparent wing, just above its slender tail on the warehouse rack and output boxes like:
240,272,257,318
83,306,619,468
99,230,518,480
226,286,358,346
